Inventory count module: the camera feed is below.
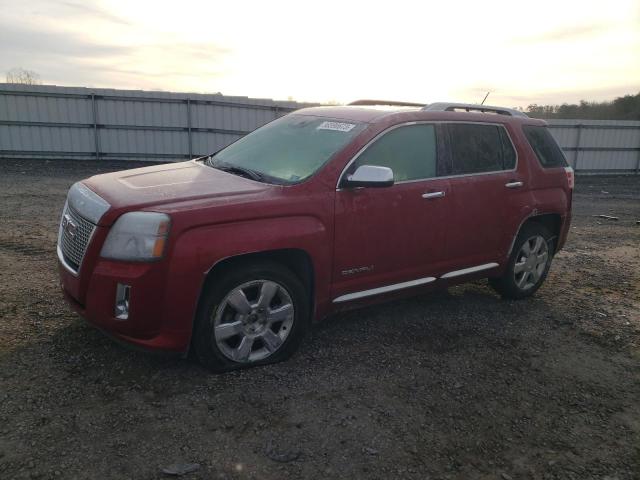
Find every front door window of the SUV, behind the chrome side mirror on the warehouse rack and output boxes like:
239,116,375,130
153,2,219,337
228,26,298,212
350,124,437,182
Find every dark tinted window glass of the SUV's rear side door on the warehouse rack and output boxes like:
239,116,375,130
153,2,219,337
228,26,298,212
449,123,503,175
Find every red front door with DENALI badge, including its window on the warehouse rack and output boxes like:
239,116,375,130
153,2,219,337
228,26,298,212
333,123,450,302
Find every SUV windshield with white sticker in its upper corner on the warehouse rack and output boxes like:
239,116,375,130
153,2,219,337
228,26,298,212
207,114,366,183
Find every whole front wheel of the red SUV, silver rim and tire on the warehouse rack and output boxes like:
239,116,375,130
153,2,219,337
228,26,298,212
194,262,309,372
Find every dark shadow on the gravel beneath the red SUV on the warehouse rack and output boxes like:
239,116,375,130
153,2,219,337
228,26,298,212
16,281,552,384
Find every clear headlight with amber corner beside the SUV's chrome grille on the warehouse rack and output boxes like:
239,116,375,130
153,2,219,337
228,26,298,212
100,212,170,262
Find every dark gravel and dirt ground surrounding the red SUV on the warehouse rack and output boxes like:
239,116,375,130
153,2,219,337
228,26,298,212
0,160,640,480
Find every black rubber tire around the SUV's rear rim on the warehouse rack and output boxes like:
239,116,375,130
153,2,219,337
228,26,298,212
489,223,554,299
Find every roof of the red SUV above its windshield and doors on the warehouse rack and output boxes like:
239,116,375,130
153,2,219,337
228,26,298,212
293,106,546,125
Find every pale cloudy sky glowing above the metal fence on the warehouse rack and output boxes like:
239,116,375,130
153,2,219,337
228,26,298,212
0,0,640,107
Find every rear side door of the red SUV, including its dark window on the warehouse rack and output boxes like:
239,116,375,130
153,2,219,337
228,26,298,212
446,122,524,269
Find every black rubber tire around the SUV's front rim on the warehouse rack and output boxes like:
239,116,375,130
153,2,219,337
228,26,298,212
192,261,310,372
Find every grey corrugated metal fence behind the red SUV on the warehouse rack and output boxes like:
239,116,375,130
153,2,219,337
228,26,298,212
0,84,640,173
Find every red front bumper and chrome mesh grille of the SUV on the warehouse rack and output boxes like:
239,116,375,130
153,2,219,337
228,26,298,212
57,182,197,352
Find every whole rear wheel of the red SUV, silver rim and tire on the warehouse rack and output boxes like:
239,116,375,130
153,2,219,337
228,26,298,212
489,224,553,299
